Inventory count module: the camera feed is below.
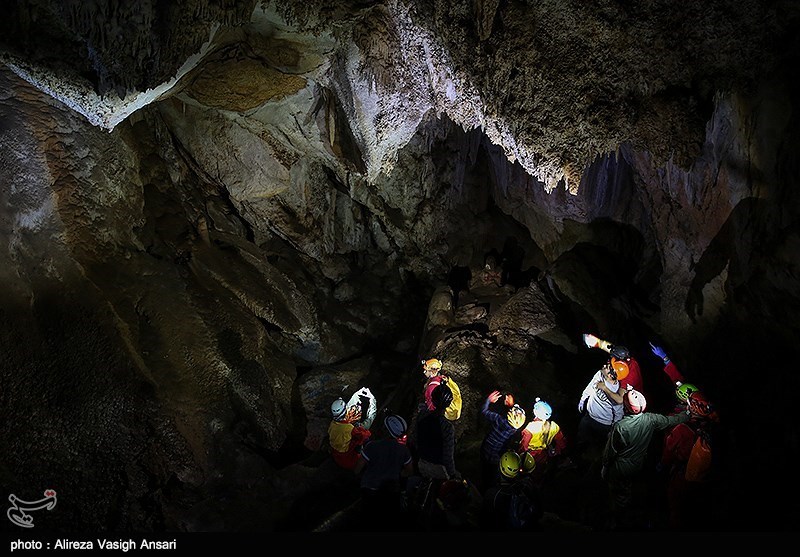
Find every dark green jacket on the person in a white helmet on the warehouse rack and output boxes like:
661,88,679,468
603,412,689,478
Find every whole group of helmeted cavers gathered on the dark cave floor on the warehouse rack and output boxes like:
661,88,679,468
328,334,719,531
